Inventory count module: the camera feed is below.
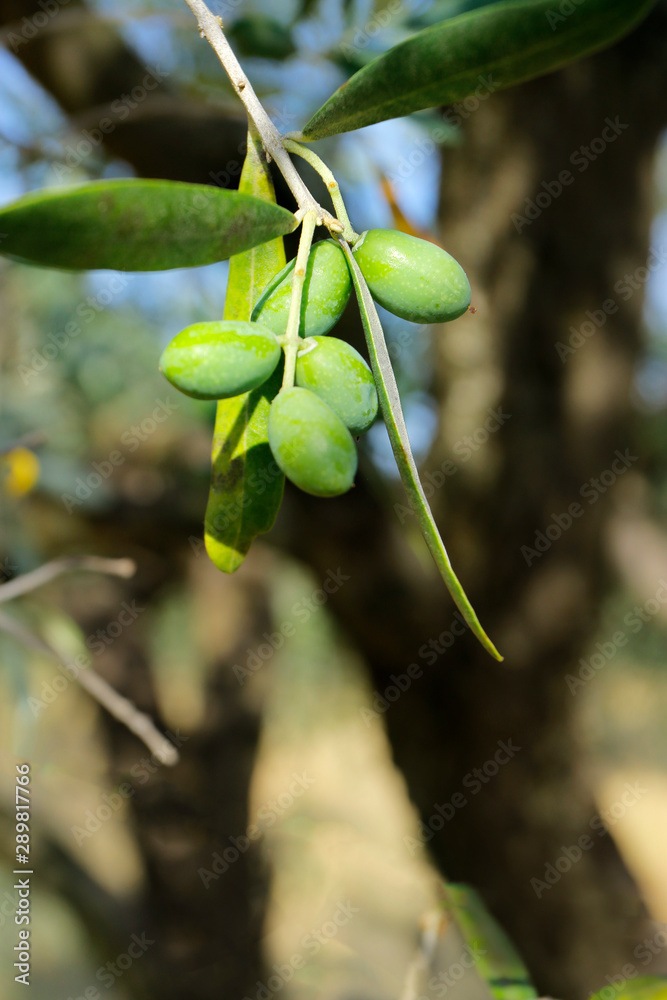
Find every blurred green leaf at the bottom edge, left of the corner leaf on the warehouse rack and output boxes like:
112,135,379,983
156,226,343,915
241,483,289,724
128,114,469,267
444,883,536,1000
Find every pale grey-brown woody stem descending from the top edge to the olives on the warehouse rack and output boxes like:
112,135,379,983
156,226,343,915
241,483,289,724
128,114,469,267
180,0,342,233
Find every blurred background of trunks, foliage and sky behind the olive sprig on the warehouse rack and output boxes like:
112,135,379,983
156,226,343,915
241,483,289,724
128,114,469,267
0,0,667,1000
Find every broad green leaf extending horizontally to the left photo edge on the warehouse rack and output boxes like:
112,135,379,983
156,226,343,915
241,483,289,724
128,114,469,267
0,180,294,271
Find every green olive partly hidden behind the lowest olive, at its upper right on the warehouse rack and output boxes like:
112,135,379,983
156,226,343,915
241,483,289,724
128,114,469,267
296,337,378,435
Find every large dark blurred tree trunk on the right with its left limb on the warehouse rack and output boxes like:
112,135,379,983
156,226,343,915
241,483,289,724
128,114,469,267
284,7,667,998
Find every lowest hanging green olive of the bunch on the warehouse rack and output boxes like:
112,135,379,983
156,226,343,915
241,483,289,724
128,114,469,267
269,386,357,497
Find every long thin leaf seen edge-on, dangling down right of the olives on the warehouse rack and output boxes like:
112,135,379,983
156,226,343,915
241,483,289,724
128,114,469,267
341,240,502,660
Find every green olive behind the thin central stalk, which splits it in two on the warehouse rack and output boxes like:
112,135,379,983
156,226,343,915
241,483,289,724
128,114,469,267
252,240,352,337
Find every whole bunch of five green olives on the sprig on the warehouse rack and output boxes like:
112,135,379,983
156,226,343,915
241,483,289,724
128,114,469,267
160,229,470,497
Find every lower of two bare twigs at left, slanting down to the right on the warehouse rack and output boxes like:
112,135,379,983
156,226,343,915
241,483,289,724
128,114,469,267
0,611,179,767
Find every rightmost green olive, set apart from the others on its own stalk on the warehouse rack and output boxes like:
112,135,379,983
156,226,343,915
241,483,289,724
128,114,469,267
353,229,470,323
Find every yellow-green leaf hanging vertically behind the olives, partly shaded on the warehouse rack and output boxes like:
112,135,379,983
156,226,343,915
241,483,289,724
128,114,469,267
205,132,285,573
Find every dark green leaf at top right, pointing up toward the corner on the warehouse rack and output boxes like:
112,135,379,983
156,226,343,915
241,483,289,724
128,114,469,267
301,0,655,141
